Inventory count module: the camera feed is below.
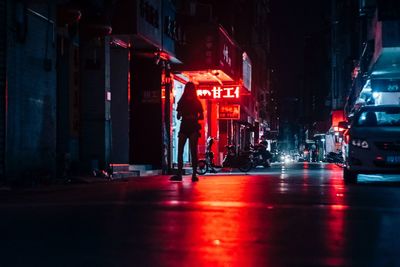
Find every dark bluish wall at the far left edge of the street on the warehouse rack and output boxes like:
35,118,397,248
0,1,57,184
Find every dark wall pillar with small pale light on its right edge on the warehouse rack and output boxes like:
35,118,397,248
80,37,111,171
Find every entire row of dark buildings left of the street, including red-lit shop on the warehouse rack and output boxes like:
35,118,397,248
0,0,270,183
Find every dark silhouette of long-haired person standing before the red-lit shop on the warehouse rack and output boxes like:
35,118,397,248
170,82,204,182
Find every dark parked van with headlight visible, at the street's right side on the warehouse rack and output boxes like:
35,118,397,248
343,105,400,183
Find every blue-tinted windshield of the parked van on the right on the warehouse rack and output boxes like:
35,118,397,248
355,108,400,127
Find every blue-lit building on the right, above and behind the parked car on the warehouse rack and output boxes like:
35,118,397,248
330,0,400,157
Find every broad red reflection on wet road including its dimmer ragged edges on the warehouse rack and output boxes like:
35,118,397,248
162,176,274,266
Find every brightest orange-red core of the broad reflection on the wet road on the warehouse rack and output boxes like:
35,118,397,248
191,176,255,266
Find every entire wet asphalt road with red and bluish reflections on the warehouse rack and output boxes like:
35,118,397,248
0,163,400,267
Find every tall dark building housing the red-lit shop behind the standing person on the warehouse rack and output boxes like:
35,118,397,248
173,0,277,163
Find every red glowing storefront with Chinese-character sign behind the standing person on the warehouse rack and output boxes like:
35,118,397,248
173,24,255,164
